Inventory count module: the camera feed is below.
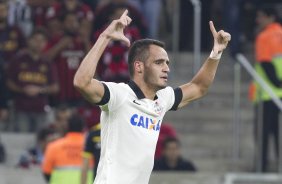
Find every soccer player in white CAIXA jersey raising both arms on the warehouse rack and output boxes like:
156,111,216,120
74,10,231,184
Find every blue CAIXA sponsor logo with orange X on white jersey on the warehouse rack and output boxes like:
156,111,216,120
130,114,161,131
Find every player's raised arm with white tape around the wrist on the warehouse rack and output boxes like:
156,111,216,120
178,21,231,108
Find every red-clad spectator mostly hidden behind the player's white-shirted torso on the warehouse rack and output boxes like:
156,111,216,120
155,122,177,159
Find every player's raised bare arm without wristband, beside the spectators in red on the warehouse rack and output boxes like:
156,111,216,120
73,10,131,103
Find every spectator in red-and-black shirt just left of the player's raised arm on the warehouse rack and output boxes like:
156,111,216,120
47,13,90,107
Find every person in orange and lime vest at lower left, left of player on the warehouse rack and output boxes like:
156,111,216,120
42,115,92,184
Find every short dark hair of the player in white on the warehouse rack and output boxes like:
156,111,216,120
128,38,165,77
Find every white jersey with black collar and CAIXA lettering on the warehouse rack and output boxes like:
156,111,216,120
94,81,182,184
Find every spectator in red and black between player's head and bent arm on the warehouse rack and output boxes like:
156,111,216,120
95,4,141,82
